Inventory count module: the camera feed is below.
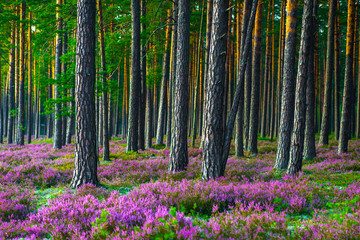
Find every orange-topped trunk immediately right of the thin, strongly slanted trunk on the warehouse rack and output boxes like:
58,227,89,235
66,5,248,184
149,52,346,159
249,0,264,154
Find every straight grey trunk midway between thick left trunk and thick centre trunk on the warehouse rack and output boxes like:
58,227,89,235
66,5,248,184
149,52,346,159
126,0,141,152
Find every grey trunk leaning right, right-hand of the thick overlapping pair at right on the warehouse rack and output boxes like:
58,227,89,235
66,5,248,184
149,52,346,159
287,0,314,174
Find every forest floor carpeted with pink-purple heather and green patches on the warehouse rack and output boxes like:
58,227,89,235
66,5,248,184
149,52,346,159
0,136,360,239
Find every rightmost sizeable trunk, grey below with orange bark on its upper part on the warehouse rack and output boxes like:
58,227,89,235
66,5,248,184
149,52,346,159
338,0,355,153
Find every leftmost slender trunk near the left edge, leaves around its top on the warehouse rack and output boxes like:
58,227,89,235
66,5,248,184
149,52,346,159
7,21,15,144
